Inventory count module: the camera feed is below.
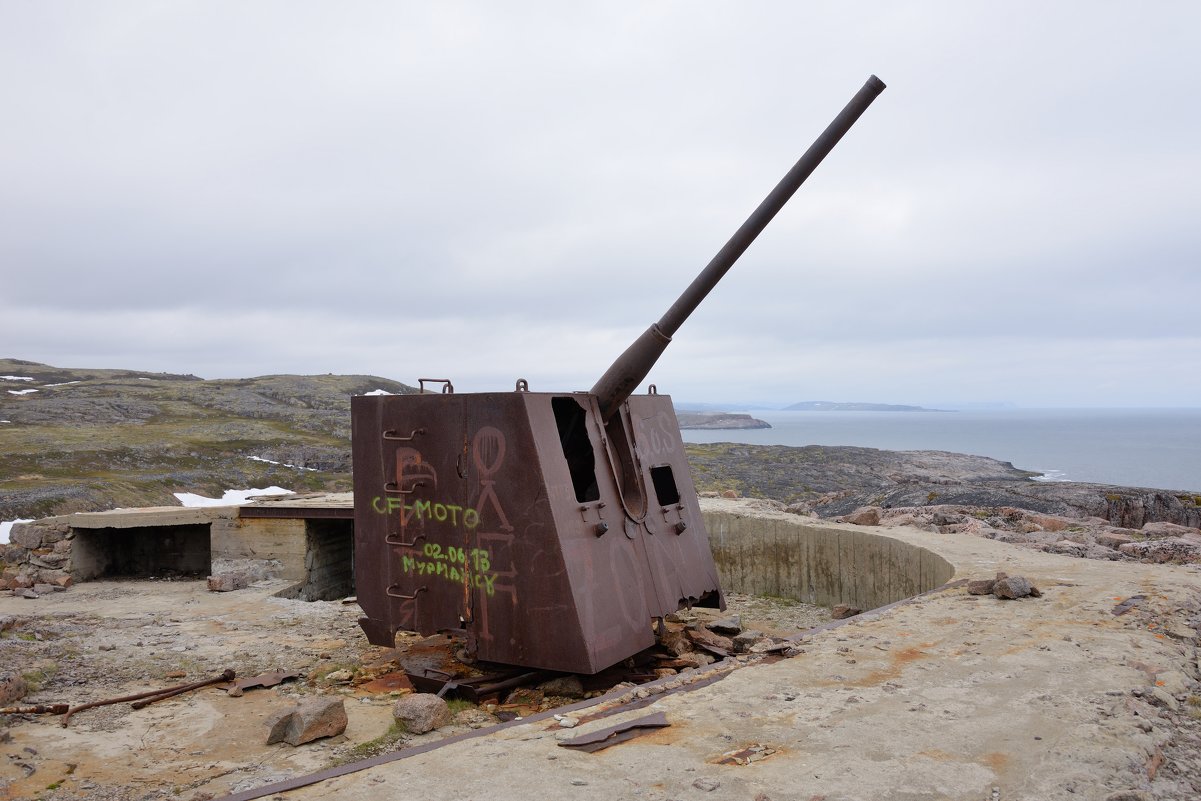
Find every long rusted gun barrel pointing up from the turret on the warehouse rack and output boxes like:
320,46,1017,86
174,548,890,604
592,76,884,420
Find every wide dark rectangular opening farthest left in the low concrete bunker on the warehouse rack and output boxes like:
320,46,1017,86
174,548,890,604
71,524,211,581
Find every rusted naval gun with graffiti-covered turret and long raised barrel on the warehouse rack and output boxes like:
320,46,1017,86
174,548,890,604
351,76,884,674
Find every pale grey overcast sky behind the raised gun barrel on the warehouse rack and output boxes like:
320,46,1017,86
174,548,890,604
0,0,1201,406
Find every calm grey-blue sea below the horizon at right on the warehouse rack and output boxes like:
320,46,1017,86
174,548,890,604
683,408,1201,492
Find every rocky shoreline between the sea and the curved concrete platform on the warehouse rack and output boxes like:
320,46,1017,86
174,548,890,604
688,443,1201,563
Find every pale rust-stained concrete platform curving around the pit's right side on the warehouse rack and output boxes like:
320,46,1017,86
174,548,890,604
231,501,1201,801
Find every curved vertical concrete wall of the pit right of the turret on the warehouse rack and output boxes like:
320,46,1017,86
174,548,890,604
704,510,955,611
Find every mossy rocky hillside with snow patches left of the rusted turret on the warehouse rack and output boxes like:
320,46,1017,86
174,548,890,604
0,359,416,520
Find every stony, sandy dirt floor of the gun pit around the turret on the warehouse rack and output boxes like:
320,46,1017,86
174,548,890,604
0,580,829,801
